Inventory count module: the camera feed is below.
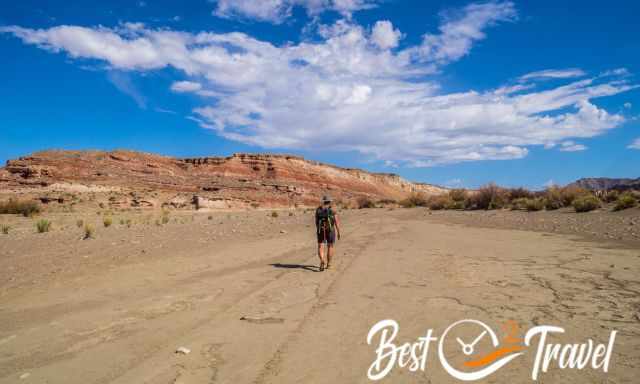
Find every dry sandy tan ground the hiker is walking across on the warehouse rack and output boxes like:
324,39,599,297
0,209,640,383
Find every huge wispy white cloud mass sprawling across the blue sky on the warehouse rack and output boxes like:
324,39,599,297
0,2,637,167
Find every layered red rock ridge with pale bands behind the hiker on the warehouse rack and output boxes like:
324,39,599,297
0,151,446,209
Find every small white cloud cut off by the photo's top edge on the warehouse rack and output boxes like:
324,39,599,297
213,0,379,24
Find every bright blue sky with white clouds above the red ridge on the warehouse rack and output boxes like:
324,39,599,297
0,0,640,188
